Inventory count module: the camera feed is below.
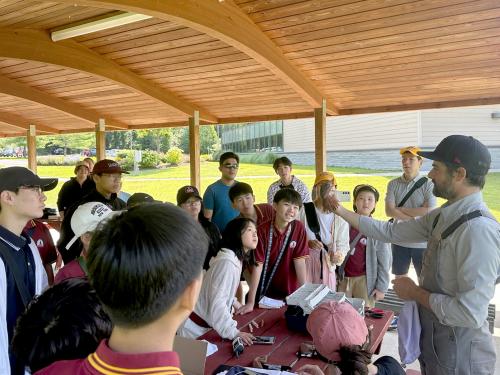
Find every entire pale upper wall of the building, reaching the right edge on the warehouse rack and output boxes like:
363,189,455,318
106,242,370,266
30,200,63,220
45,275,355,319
283,105,500,152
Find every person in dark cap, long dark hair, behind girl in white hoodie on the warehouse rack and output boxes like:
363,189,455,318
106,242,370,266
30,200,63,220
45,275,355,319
177,185,221,270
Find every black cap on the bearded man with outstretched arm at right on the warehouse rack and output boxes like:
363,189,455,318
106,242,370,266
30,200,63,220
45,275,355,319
418,135,491,176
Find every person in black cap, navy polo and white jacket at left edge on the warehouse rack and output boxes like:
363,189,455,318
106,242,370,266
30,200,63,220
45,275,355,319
0,167,57,374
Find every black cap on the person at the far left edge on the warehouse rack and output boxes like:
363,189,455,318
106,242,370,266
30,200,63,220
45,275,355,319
0,167,57,192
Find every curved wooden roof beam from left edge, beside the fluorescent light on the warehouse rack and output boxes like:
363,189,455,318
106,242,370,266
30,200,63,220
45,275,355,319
0,29,217,123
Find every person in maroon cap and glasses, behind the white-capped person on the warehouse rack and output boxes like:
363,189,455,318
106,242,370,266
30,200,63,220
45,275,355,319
57,159,128,263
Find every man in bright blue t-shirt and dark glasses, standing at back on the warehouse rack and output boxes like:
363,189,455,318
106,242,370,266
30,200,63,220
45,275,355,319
203,152,240,232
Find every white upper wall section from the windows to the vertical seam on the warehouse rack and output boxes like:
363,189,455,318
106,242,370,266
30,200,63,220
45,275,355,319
283,111,421,152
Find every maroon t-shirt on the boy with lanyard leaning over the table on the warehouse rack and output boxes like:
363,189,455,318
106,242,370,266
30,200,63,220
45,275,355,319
255,220,309,299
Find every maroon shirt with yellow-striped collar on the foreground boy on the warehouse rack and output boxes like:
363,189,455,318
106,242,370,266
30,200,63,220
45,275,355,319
35,340,182,375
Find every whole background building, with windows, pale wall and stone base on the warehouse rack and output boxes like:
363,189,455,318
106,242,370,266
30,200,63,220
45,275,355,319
219,105,500,169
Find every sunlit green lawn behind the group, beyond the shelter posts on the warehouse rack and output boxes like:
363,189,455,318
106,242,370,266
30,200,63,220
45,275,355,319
38,162,500,219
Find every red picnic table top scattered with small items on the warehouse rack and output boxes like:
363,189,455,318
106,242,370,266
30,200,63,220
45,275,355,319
198,307,394,374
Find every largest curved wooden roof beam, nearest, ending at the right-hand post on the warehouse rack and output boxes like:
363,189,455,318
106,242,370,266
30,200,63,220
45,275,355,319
52,0,337,114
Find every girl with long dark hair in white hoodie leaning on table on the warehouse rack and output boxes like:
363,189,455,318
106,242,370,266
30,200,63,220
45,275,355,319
177,218,258,345
